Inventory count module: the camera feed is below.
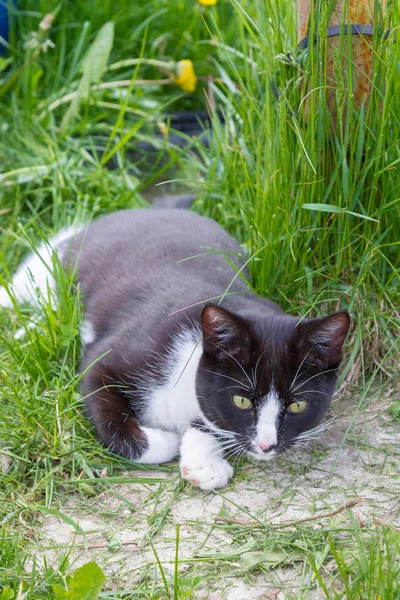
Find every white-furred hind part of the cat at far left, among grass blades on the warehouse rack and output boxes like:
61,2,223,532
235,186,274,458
0,226,79,308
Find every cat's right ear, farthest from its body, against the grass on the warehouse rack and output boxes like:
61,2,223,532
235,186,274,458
298,311,350,369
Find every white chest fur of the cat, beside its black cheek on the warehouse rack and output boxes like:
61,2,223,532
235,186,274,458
140,330,203,434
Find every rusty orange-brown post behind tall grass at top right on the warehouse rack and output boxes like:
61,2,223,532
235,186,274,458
297,0,386,130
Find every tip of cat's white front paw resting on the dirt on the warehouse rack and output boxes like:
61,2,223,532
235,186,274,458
181,455,233,490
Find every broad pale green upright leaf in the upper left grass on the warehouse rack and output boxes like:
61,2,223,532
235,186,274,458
60,21,114,132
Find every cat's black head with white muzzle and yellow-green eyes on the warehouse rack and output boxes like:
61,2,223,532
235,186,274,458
196,305,350,460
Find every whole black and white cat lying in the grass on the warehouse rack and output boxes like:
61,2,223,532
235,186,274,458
0,209,349,490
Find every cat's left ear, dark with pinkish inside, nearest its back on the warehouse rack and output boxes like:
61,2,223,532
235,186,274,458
201,304,251,362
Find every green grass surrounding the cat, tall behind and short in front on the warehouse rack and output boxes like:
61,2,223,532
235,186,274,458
0,0,400,600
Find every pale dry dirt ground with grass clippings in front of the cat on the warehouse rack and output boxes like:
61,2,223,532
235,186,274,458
35,400,400,600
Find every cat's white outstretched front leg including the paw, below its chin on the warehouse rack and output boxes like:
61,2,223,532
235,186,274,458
181,427,233,490
